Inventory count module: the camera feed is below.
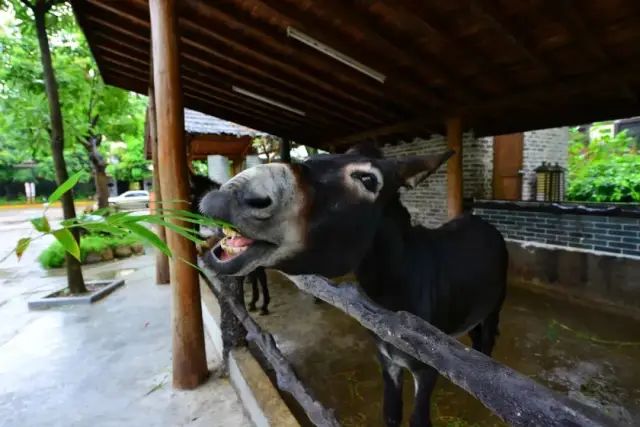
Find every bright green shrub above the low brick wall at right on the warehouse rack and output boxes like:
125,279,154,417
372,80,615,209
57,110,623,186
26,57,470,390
567,126,640,203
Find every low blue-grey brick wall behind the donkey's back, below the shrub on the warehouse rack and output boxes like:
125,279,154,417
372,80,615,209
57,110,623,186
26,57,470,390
474,208,640,257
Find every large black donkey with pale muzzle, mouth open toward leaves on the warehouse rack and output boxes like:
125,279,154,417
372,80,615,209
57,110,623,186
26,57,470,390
200,145,508,426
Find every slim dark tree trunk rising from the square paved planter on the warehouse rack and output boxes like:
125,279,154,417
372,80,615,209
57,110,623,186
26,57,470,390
33,4,87,294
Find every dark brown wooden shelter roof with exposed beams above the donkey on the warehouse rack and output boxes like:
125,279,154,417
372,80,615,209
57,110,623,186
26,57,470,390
72,0,640,147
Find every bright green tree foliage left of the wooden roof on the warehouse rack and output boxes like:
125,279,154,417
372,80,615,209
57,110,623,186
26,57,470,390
0,0,149,182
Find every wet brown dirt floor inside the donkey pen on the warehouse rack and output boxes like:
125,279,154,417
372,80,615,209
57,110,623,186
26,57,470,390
245,272,640,427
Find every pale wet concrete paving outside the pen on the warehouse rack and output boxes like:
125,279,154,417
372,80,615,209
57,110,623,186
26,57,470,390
0,224,250,427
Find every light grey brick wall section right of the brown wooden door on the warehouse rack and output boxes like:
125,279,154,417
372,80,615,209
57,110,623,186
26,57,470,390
522,127,569,200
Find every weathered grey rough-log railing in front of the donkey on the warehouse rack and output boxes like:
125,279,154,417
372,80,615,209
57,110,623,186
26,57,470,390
202,268,617,427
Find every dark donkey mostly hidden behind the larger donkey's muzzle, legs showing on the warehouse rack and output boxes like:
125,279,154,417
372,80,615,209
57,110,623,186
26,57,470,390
189,172,271,315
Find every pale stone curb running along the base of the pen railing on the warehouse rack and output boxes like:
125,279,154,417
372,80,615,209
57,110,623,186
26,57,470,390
200,285,300,427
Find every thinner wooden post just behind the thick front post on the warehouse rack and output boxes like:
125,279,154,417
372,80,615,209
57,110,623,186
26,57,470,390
147,88,171,285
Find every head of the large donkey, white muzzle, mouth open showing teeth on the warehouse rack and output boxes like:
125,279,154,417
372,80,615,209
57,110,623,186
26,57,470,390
200,148,452,276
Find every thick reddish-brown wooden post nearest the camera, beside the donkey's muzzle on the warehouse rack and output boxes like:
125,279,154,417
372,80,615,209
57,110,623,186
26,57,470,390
149,0,208,389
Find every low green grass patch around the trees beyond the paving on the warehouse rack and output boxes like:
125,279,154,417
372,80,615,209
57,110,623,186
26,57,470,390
38,234,142,269
